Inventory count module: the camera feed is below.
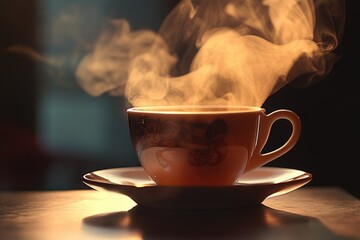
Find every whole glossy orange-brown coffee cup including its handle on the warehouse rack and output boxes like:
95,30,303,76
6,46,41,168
127,106,301,186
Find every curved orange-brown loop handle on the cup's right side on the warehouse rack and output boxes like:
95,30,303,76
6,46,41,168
244,109,301,173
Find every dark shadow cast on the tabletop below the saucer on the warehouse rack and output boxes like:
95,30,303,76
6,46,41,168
83,205,345,240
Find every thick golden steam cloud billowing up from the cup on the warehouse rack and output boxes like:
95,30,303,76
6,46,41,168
77,0,344,106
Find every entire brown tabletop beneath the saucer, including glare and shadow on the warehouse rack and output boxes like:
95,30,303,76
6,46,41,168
0,187,360,240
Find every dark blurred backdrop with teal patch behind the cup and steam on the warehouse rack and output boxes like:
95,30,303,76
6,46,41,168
0,0,360,197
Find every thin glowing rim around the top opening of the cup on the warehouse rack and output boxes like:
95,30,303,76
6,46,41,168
126,105,265,114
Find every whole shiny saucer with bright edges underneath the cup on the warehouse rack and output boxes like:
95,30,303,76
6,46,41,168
83,167,312,209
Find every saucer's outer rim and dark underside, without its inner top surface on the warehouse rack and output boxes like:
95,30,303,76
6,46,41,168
83,166,312,209
